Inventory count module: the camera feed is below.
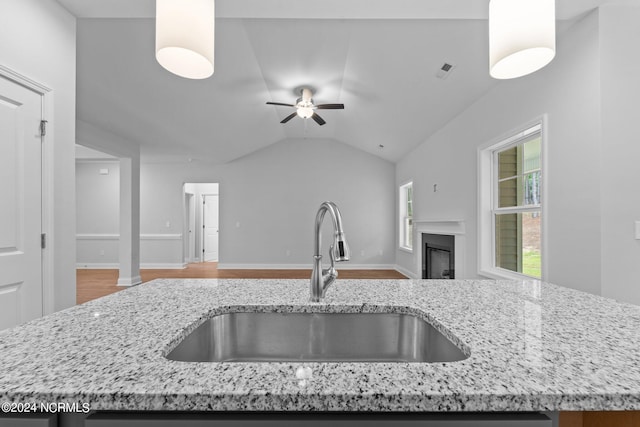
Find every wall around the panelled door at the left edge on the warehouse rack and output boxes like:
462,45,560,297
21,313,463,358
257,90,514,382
0,0,76,310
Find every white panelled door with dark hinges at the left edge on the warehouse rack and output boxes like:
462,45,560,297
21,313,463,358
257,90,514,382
0,77,42,330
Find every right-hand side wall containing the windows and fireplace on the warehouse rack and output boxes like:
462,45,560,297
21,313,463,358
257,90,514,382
396,11,601,293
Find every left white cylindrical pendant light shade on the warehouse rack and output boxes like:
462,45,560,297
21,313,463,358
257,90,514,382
156,0,215,79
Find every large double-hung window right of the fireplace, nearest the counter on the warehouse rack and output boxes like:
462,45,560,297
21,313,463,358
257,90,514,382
479,123,543,279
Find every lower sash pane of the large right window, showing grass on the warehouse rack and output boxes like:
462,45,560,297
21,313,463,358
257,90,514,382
495,212,542,278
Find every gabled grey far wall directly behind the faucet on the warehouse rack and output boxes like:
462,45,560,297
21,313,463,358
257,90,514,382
219,139,395,268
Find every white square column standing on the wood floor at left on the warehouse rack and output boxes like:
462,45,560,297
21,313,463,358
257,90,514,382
118,157,142,286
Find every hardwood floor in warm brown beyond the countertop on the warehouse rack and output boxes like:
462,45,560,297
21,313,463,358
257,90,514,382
76,262,406,304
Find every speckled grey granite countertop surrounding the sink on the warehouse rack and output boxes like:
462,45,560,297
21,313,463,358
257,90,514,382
0,279,640,411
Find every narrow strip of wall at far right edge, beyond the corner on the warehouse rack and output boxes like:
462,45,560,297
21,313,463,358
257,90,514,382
600,1,640,304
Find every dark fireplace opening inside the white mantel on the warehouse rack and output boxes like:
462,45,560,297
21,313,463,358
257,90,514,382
422,233,456,279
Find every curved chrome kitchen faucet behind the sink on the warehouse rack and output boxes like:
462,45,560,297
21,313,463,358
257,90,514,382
311,202,351,302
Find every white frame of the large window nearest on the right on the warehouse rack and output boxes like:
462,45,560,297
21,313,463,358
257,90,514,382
478,115,549,280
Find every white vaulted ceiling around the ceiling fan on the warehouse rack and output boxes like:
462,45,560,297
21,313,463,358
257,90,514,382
59,0,606,163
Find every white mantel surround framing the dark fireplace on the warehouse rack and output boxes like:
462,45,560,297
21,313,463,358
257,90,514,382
413,219,467,279
